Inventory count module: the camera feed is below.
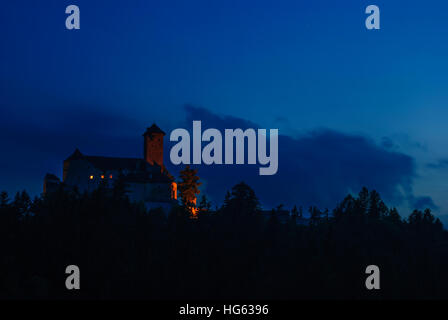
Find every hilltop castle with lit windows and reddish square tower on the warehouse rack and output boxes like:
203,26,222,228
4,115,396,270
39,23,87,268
44,124,177,209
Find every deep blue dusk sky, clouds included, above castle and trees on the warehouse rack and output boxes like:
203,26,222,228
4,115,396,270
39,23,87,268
0,0,448,214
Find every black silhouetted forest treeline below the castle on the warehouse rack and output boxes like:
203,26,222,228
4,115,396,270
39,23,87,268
0,183,448,300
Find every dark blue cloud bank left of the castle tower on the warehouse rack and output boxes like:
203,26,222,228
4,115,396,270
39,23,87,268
0,99,144,195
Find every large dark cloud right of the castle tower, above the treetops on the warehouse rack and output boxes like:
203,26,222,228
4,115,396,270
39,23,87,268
165,106,434,208
